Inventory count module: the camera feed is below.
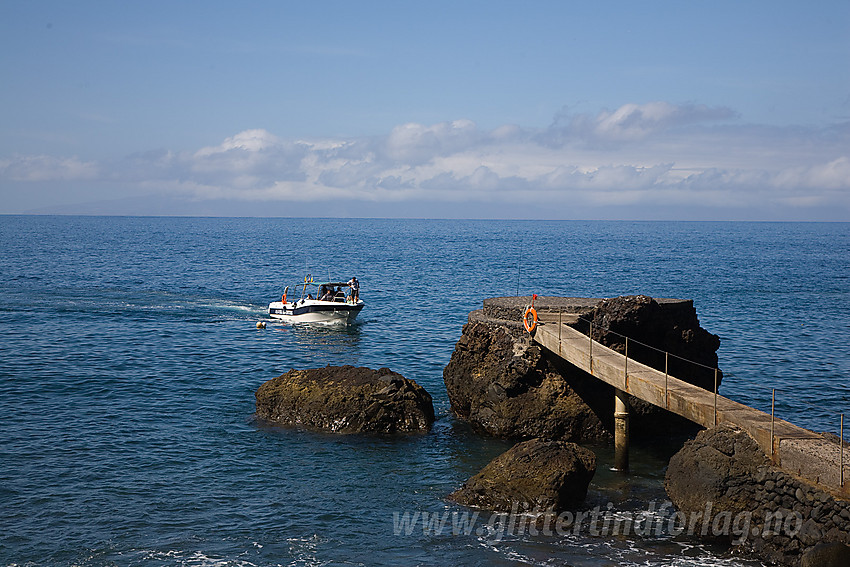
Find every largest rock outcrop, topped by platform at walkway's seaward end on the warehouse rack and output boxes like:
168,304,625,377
443,296,720,442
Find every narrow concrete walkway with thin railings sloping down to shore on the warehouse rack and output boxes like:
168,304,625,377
533,312,850,496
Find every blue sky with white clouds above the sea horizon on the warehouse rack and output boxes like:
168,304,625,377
0,0,850,220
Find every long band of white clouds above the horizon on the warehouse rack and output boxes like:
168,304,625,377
0,102,850,220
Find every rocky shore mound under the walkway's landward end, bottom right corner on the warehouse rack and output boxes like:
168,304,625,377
665,426,850,566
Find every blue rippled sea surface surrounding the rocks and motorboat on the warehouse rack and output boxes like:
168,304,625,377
0,216,850,566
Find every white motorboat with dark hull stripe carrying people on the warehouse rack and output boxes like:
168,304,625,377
269,275,365,324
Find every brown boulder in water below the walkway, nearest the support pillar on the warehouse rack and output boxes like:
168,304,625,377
449,439,596,512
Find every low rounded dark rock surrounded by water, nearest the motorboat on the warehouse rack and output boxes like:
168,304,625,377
256,366,434,433
